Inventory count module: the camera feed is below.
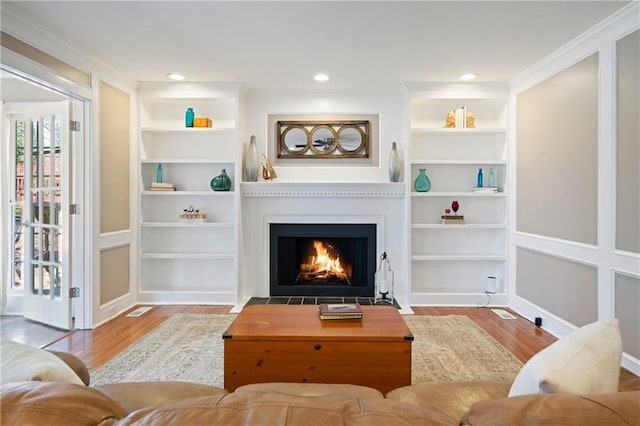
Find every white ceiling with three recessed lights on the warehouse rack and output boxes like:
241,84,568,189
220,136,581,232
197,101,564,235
3,0,626,89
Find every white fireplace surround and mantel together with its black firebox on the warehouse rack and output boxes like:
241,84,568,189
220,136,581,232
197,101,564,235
239,182,407,300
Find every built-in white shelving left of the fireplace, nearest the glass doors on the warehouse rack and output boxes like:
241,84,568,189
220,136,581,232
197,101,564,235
138,84,242,304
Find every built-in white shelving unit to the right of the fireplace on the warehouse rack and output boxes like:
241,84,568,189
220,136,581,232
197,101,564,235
405,84,508,305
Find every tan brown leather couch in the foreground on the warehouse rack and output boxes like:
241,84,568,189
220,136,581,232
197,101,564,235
0,354,640,426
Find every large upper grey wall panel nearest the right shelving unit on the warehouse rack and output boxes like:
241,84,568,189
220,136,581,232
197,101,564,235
516,54,598,245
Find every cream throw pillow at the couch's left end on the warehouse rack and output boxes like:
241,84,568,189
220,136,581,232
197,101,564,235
0,339,84,385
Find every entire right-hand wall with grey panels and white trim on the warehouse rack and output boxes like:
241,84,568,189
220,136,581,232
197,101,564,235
509,16,640,374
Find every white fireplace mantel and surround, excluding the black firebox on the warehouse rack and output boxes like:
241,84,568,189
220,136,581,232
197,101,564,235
239,181,408,304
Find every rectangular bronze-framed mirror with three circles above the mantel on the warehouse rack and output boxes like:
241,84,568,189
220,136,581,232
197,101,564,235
276,120,370,159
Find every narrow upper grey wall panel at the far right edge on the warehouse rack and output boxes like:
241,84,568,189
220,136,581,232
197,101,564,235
616,31,640,253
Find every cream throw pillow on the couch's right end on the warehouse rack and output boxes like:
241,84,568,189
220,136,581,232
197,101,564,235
509,319,622,396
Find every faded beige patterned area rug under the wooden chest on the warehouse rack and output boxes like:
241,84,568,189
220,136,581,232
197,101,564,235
91,314,522,387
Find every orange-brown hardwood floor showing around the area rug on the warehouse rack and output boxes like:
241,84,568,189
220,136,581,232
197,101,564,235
45,305,556,372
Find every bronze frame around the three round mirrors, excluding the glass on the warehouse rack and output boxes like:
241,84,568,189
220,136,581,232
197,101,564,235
276,120,370,159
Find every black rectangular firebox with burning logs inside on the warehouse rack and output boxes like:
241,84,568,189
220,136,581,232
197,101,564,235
269,223,376,297
